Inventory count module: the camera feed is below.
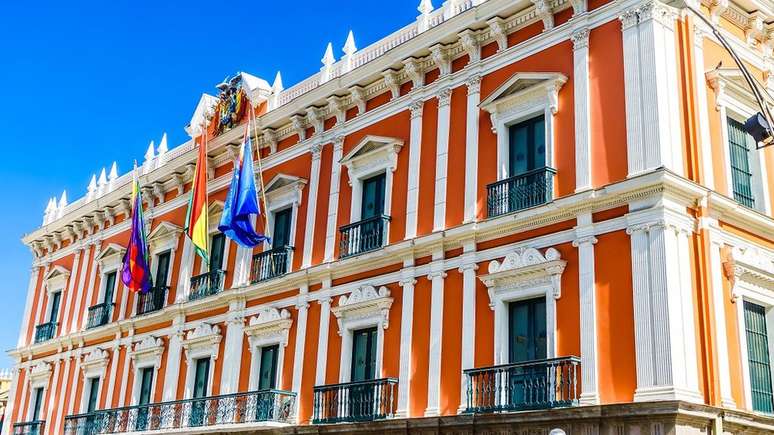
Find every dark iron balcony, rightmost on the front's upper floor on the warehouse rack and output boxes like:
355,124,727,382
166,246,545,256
486,167,556,217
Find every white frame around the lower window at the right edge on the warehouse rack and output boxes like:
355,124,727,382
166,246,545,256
726,246,774,411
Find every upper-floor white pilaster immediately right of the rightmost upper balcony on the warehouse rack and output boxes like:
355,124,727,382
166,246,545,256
571,28,592,192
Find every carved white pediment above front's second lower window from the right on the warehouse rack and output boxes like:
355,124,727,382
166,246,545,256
331,285,393,335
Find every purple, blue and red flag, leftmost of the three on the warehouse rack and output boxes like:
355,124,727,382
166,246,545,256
121,163,151,293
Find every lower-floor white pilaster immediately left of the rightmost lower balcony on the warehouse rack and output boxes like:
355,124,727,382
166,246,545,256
457,247,478,413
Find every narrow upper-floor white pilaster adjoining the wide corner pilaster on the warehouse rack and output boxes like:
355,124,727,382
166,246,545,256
618,9,645,177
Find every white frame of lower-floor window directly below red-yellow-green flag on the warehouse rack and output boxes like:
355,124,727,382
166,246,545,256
183,322,223,399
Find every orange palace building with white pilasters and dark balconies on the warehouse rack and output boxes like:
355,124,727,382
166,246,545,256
4,0,774,434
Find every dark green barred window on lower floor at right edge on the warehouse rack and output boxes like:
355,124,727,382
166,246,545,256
744,301,774,413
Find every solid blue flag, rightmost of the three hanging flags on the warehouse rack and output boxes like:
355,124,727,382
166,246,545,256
218,124,268,248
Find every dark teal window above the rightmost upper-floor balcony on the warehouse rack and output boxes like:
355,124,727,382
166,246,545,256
508,114,546,177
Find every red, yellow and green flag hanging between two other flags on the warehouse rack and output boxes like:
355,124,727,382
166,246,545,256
185,133,210,263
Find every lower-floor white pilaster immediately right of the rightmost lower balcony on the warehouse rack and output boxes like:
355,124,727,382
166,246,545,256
572,218,599,405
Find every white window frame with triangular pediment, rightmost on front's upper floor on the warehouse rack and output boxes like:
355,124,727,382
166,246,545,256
479,72,567,181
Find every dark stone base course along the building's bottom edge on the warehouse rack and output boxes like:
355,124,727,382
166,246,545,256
217,402,774,435
